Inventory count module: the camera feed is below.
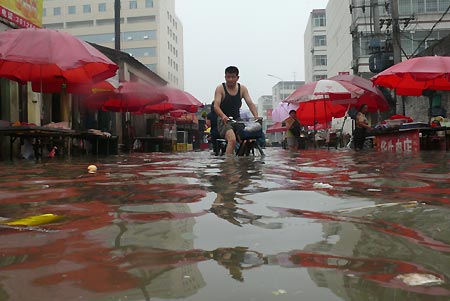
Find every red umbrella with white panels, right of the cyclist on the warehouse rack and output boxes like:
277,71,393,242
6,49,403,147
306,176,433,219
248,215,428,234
283,79,364,103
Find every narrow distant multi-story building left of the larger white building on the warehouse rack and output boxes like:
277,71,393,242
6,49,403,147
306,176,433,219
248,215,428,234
304,9,328,82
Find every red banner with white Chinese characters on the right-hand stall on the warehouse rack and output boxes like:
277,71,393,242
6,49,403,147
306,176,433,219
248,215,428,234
376,130,420,154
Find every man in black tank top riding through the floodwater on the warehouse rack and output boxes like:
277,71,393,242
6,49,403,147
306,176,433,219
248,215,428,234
214,66,258,155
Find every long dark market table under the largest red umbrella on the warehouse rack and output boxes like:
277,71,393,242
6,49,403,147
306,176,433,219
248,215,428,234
0,126,75,160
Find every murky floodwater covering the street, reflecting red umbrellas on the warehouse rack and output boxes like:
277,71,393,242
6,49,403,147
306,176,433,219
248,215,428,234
0,148,450,301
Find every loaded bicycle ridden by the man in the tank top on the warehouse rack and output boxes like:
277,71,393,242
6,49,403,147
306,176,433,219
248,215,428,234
217,117,265,157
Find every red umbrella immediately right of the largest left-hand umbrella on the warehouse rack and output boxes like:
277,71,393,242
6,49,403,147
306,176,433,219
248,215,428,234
83,82,166,112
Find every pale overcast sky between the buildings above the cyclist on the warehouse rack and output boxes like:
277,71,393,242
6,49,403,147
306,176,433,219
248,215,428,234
176,0,328,103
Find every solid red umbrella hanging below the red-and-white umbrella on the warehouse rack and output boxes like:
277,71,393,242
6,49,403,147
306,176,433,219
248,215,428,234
297,99,347,125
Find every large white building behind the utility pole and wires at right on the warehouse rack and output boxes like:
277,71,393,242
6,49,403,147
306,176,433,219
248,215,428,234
324,0,450,78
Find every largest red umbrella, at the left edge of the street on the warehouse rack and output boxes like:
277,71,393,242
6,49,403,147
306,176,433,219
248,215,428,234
0,28,118,92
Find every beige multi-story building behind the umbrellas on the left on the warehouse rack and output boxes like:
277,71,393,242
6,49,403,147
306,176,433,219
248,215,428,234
43,0,184,89
